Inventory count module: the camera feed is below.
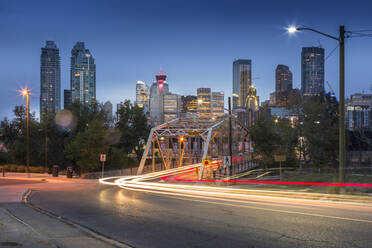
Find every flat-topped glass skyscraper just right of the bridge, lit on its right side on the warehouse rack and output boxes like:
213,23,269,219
233,59,252,108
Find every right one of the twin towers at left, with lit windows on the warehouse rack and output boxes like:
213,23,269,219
70,42,96,104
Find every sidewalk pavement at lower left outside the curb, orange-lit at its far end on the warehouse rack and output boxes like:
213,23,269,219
0,173,128,248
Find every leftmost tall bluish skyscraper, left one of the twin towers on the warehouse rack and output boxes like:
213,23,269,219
40,40,61,118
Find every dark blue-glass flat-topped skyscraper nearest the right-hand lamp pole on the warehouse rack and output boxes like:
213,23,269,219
301,47,324,95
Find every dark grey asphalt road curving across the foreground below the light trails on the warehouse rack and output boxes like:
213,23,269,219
31,182,372,248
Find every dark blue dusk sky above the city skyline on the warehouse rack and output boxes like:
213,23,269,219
0,0,372,118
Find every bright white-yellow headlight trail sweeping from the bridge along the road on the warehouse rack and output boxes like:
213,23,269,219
100,165,372,223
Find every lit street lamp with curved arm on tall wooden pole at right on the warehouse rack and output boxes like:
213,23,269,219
287,26,346,183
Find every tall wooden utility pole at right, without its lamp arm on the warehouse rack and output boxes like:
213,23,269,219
338,26,346,183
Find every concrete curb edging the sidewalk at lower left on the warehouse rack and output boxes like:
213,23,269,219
22,189,134,248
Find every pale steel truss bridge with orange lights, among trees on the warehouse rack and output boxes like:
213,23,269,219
137,115,253,179
